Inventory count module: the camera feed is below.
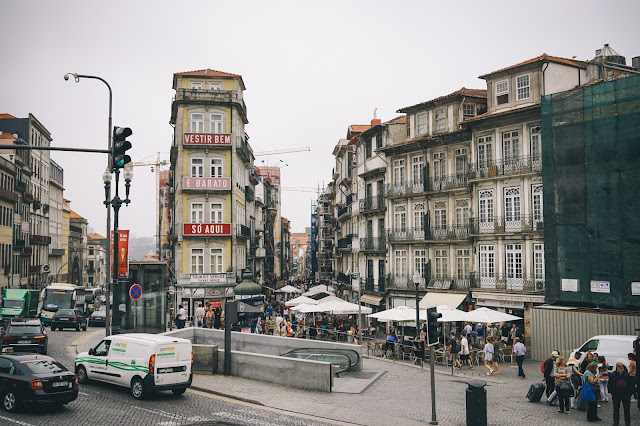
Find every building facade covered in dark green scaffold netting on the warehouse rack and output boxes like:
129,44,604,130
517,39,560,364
541,74,640,310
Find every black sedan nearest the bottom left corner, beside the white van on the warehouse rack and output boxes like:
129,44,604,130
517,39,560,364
0,352,78,411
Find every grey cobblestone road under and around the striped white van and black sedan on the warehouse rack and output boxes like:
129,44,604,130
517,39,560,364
0,328,325,426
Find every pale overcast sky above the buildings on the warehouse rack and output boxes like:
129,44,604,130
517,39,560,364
0,0,640,236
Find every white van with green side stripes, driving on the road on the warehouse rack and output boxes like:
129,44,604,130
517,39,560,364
76,333,193,399
